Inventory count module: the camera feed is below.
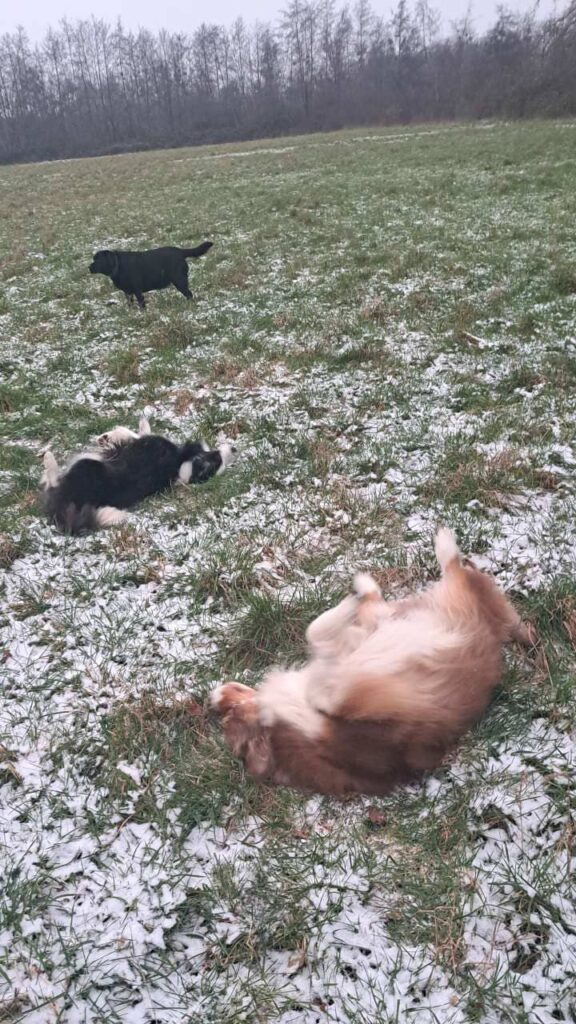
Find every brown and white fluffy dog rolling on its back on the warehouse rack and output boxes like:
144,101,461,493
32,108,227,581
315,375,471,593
211,529,532,796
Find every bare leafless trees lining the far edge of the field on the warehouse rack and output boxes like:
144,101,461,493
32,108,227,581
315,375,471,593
0,0,576,163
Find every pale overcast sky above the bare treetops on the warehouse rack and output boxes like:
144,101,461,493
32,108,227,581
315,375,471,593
0,0,567,39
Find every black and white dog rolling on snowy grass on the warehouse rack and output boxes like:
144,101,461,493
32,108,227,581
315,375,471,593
41,419,236,534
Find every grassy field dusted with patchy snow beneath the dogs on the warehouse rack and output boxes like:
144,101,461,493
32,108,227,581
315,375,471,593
0,123,576,1024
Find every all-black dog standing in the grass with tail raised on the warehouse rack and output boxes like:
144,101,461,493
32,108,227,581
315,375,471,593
90,242,212,309
